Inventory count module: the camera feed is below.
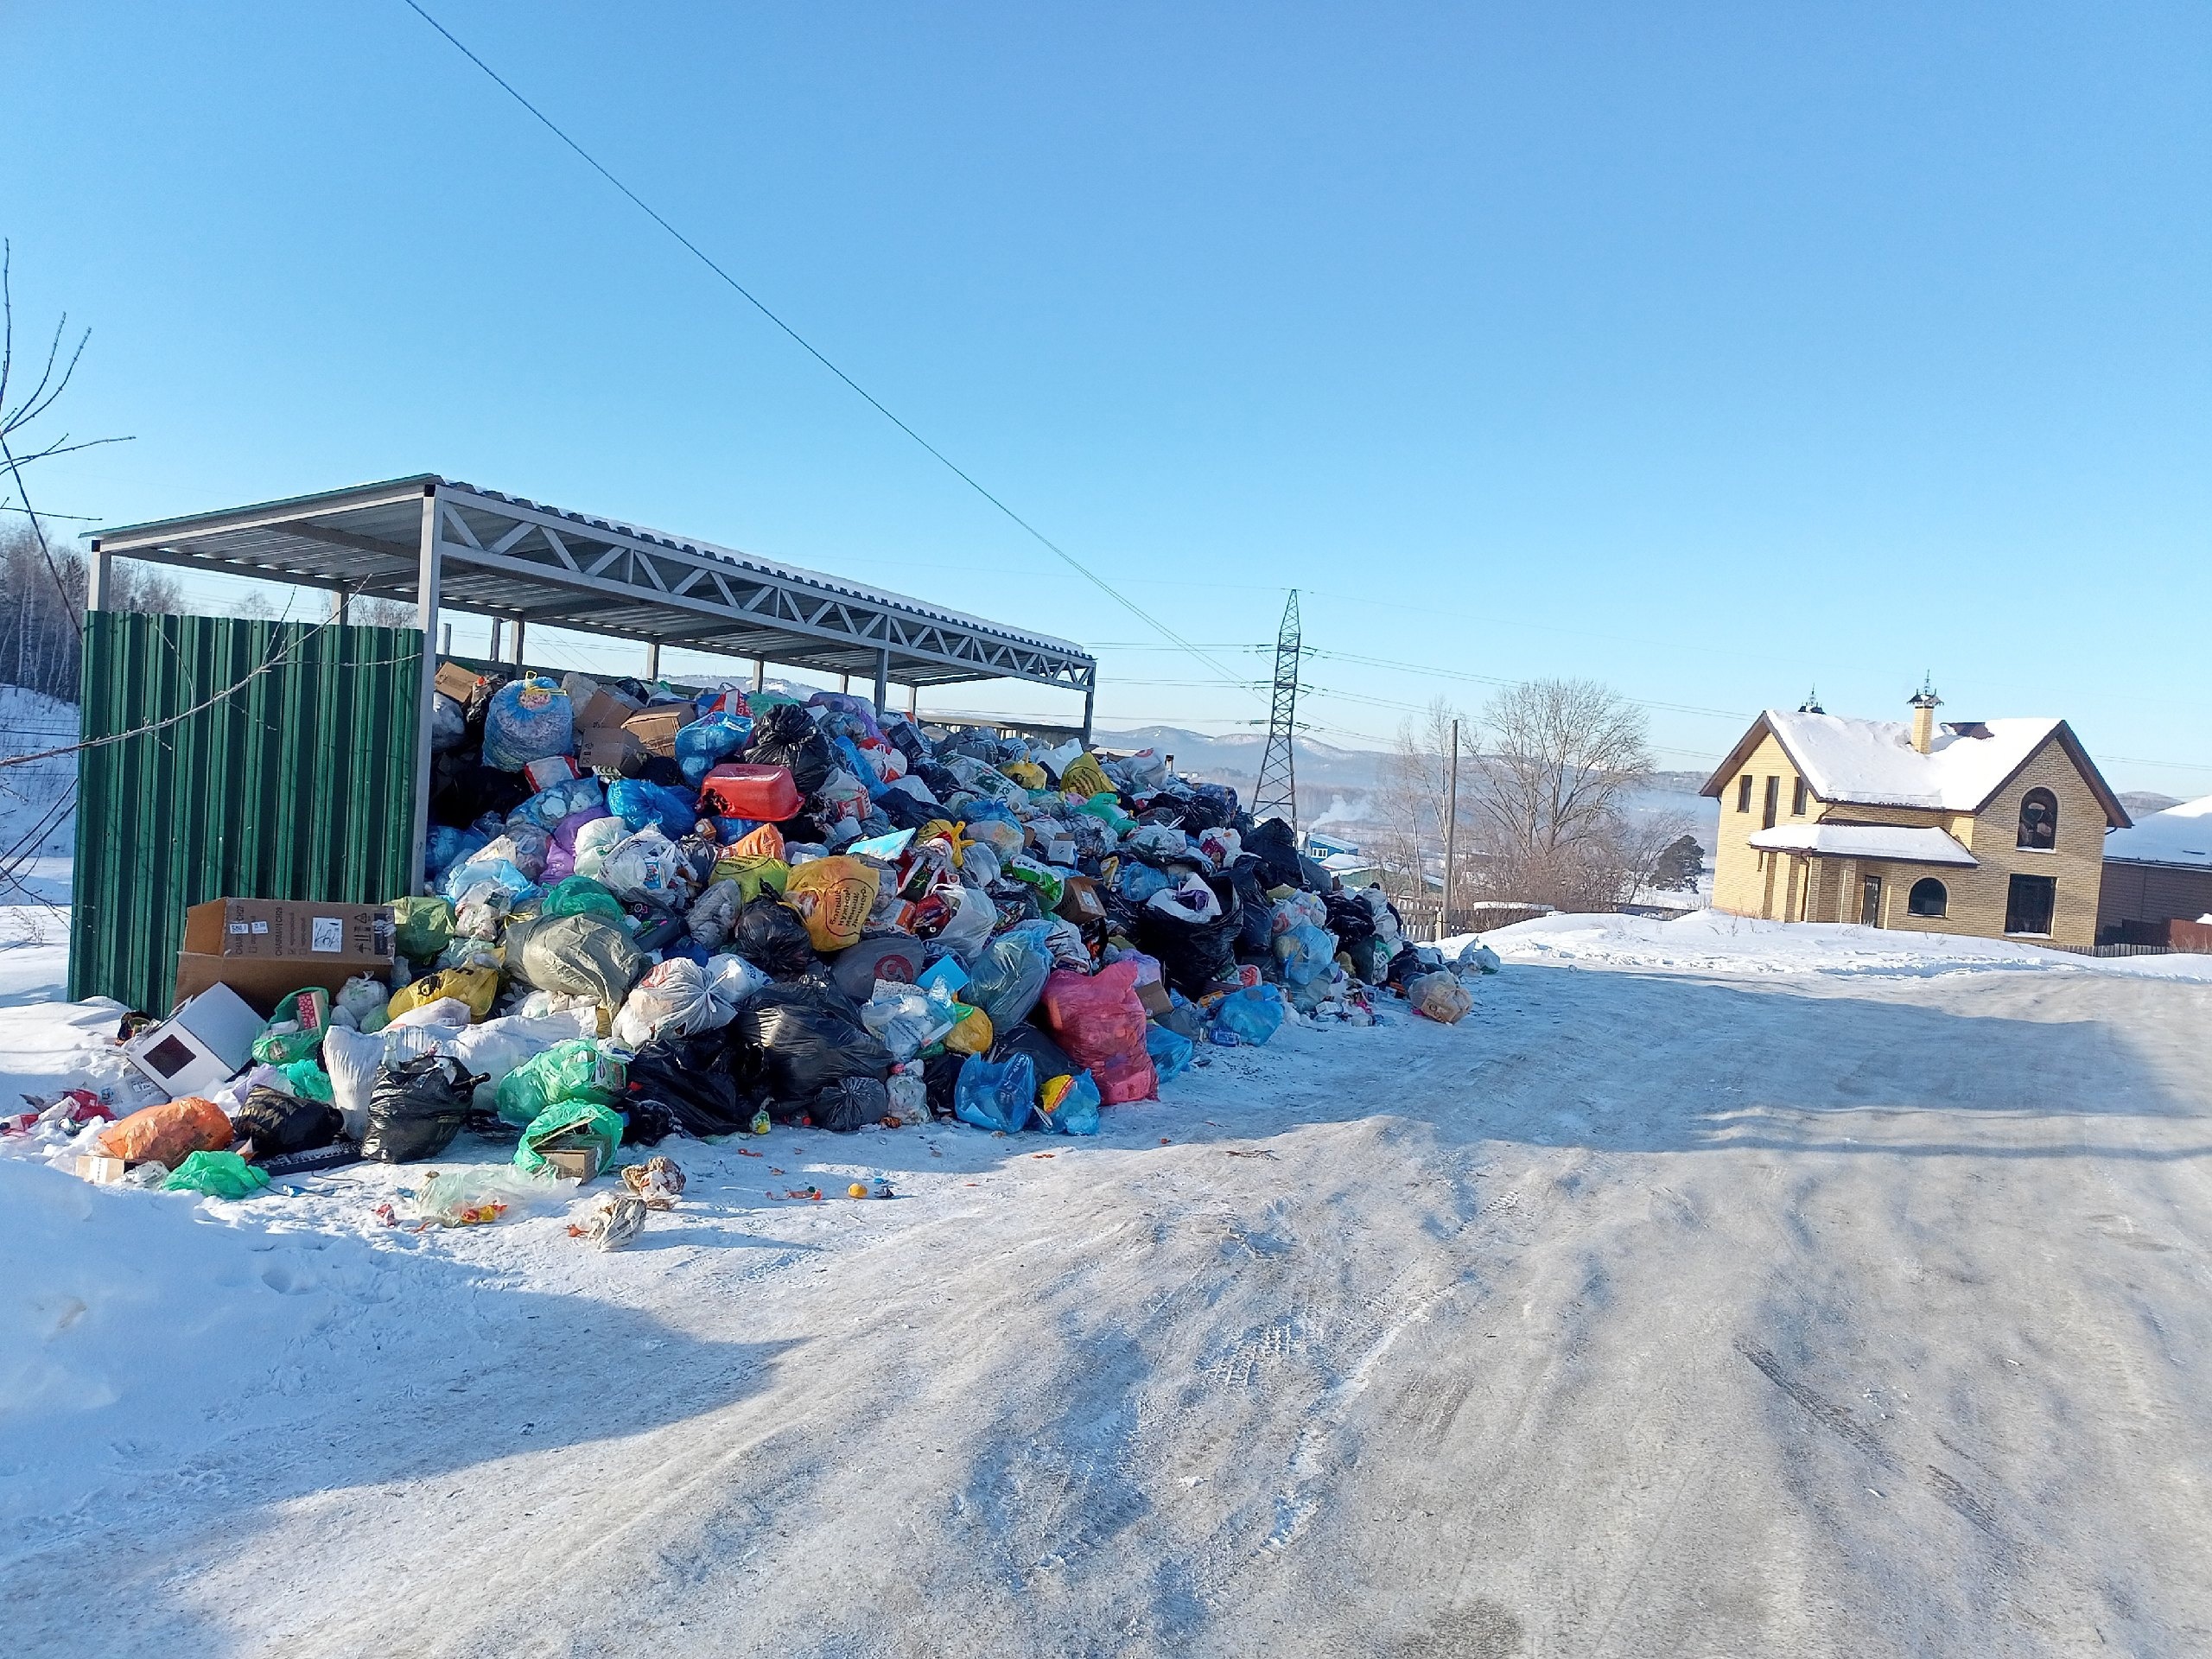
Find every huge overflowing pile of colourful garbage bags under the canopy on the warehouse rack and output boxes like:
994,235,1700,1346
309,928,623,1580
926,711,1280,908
69,677,1496,1190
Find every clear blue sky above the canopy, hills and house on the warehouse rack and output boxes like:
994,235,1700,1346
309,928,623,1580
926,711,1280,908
0,0,2212,794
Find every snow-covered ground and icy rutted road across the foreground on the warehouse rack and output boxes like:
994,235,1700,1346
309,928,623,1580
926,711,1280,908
0,913,2212,1659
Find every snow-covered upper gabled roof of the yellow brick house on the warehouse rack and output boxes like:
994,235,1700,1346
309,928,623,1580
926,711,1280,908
1701,708,2133,830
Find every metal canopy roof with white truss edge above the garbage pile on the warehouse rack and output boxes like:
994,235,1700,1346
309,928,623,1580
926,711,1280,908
93,474,1097,692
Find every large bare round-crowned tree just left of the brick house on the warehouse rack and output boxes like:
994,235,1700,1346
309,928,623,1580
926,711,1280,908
1473,679,1681,909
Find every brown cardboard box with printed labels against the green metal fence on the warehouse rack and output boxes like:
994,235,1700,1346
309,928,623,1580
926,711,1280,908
177,898,396,1013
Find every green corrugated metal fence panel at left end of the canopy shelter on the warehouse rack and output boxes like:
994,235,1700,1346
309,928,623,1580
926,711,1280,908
68,611,423,1013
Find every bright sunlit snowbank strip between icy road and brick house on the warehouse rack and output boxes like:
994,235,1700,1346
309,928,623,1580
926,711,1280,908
1445,909,2212,980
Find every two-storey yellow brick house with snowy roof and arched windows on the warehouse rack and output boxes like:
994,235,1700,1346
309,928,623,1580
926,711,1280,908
1703,688,2130,944
